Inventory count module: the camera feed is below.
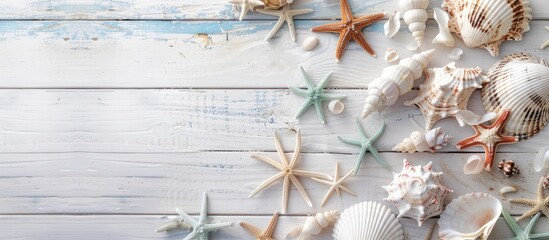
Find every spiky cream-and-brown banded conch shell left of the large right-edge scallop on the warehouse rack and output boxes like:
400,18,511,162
404,63,488,130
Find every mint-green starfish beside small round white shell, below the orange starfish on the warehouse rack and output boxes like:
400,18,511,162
290,66,345,124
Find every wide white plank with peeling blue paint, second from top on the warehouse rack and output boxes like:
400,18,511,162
0,21,549,88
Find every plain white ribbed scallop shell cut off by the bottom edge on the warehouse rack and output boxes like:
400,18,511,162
332,201,404,240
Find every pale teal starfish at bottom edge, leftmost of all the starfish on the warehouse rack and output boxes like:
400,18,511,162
157,193,233,240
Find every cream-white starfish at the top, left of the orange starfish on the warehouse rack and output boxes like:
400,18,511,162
257,4,313,42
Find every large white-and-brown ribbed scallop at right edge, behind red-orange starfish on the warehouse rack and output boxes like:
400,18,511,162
482,53,549,141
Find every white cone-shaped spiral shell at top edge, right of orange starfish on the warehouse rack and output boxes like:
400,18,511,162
398,0,429,47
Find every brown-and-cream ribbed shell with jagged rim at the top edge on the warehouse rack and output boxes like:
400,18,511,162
442,0,532,56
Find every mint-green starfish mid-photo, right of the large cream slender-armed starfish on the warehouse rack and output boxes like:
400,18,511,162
338,118,391,174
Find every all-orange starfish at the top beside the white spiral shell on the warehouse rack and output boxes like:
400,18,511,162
311,0,385,61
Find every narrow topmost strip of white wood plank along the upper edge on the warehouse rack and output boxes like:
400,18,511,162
0,0,549,20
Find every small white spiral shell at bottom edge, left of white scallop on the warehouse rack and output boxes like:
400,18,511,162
286,211,339,240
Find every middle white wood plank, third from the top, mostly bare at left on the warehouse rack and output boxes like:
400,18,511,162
0,90,549,154
